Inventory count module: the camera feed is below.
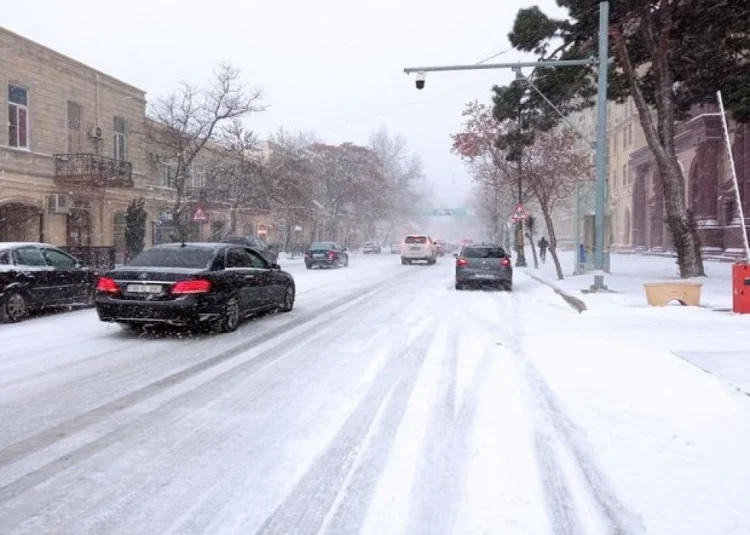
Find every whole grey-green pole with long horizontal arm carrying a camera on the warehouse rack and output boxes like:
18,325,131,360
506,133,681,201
404,0,609,292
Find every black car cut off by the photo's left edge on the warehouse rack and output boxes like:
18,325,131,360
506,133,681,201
0,242,97,322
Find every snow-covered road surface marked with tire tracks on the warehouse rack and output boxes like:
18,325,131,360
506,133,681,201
0,255,750,535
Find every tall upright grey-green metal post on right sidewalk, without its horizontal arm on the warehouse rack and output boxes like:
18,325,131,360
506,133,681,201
591,1,609,292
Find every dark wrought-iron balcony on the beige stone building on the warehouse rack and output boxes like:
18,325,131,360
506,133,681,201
55,154,133,188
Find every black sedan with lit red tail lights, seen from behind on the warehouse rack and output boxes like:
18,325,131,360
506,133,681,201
96,243,296,332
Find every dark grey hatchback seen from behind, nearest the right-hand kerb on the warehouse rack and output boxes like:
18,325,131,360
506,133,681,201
456,244,513,291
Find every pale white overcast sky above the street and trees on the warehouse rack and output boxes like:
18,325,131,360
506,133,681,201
0,0,554,205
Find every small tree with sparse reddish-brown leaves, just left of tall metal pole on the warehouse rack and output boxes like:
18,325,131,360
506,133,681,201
521,129,591,279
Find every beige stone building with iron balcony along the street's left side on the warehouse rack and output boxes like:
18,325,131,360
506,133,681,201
0,27,274,266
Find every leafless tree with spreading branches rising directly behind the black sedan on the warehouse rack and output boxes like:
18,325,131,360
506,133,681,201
146,65,265,240
